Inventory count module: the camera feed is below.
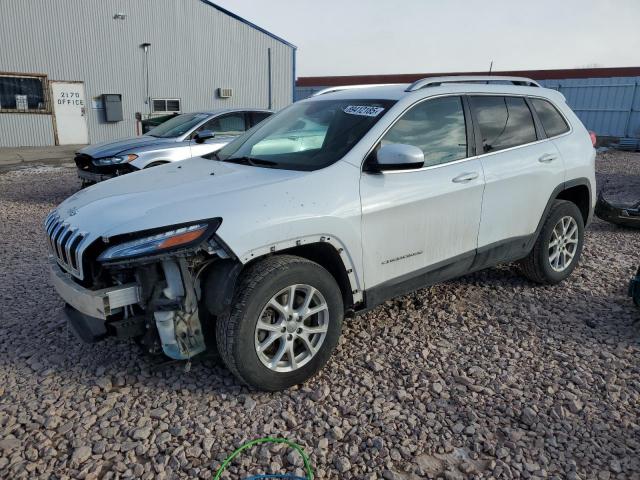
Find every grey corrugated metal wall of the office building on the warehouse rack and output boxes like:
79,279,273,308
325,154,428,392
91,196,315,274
0,0,294,146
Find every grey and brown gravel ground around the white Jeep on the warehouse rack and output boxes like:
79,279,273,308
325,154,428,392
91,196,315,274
0,152,640,480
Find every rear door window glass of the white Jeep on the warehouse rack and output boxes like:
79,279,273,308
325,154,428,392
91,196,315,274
469,95,537,153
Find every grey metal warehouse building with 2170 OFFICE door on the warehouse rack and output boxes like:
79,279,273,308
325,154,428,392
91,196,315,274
0,0,296,147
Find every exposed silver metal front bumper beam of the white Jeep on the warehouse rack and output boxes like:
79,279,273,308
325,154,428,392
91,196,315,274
49,258,140,320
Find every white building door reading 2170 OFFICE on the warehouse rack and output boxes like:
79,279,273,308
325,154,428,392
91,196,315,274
51,82,89,145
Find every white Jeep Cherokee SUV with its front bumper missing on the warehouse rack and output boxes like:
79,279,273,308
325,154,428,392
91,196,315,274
45,77,596,390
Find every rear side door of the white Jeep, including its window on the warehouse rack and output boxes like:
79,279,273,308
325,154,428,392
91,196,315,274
469,95,564,251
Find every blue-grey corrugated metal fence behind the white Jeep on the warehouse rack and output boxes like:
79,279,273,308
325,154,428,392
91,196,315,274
296,77,640,138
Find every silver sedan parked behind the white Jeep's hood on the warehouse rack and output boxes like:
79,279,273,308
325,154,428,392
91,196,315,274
75,109,272,186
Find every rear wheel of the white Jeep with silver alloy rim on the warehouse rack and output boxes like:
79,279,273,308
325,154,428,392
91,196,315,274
520,200,584,284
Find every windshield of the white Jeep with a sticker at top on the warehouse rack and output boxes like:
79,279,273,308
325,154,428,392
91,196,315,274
216,100,395,170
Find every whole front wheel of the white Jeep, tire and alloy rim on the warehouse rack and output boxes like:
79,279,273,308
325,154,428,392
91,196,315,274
216,255,344,391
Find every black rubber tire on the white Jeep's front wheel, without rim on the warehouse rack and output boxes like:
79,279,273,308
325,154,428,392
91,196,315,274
216,255,344,391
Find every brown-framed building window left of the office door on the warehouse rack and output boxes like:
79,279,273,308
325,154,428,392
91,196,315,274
0,73,49,113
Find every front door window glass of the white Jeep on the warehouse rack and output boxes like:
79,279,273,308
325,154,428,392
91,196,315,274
381,97,467,167
